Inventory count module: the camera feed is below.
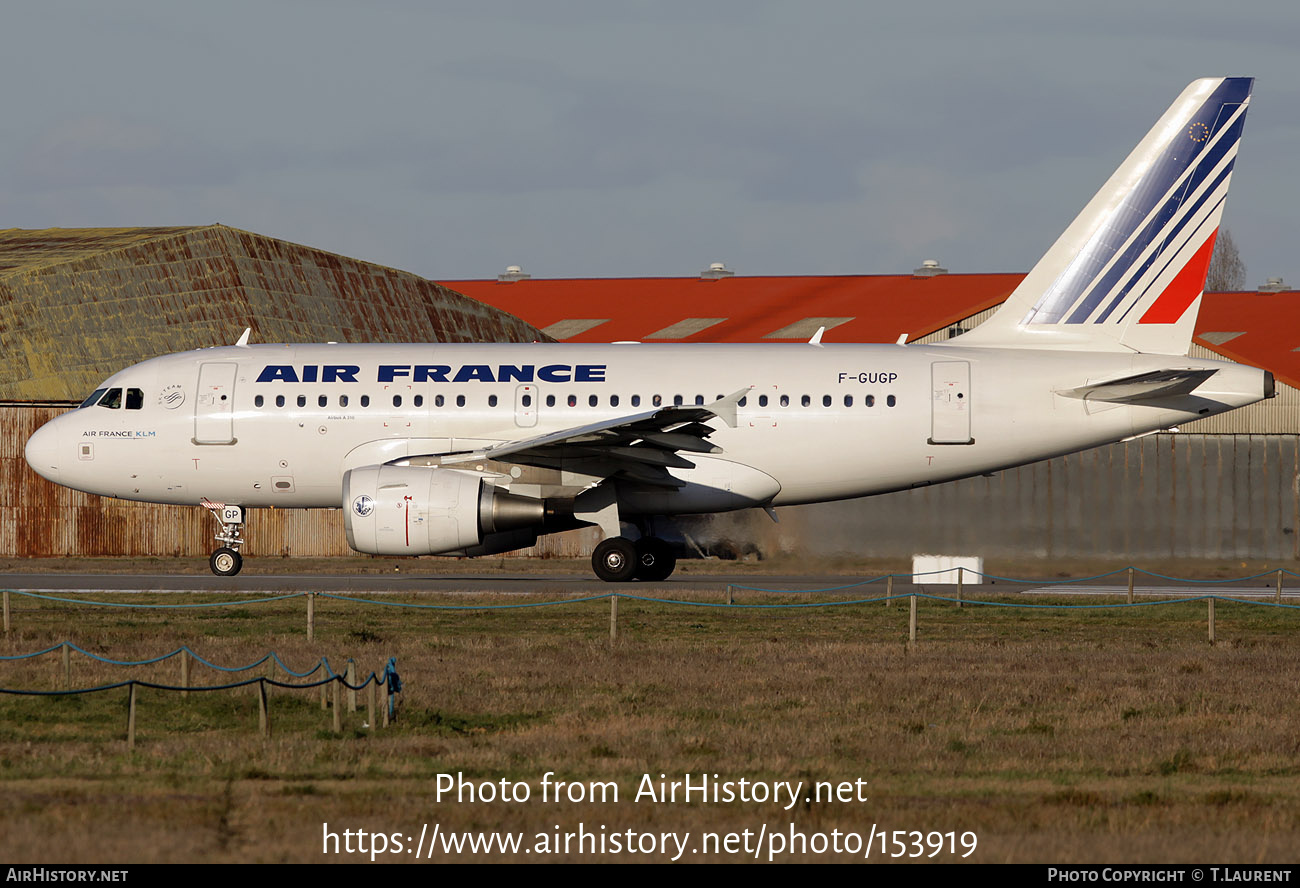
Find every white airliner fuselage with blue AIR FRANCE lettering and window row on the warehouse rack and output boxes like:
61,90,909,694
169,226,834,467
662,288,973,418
27,343,1266,515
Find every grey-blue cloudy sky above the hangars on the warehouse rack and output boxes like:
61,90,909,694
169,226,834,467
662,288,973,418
0,0,1300,287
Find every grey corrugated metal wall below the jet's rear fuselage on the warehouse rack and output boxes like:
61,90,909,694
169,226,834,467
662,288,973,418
780,433,1300,560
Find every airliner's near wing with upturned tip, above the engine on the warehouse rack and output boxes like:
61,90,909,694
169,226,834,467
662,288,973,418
441,387,749,488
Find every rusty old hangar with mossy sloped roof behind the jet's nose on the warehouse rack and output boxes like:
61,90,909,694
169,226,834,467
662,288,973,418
0,225,547,556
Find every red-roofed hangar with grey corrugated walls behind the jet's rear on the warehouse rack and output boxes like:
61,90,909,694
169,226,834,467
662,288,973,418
445,263,1300,560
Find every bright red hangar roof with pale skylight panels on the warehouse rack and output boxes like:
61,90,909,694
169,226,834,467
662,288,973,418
441,273,1300,387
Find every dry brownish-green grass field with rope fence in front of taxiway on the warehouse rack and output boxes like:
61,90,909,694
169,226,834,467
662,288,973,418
0,579,1300,863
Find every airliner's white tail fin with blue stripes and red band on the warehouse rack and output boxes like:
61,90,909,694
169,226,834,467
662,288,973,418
954,77,1255,355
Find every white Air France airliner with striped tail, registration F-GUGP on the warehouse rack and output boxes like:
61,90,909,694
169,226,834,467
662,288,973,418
26,77,1274,581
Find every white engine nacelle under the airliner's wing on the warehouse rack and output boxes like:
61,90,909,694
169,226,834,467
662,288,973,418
343,465,545,555
